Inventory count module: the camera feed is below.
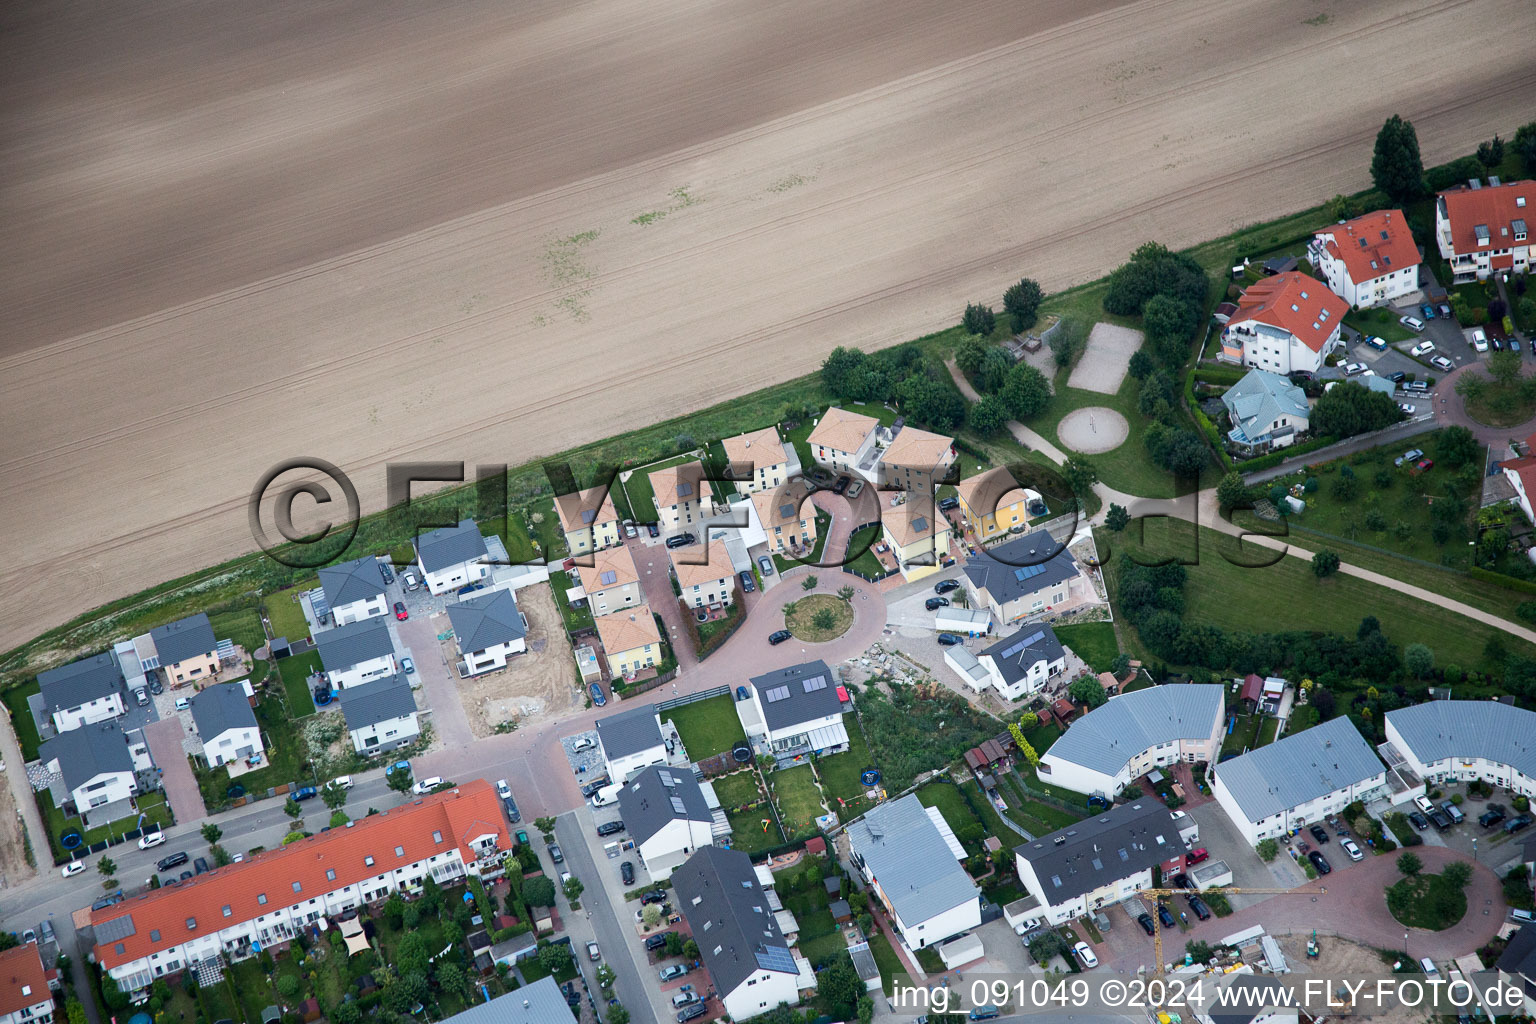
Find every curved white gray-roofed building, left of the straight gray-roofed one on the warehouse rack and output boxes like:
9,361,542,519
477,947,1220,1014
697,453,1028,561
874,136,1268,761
1037,683,1226,797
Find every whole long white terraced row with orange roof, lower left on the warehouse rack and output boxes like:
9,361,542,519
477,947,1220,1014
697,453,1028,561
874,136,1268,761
91,778,511,995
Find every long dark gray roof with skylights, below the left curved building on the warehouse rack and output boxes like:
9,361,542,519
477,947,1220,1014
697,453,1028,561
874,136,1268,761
1014,798,1186,906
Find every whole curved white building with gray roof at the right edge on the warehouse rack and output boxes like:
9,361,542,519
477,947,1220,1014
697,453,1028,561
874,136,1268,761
1387,700,1536,797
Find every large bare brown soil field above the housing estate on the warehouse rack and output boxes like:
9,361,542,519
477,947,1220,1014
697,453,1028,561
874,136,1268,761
0,0,1536,657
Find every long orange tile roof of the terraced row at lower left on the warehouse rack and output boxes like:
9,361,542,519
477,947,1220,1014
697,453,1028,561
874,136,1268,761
91,778,511,969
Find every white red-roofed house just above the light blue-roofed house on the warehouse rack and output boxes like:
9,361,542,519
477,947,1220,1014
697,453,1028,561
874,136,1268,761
1221,270,1349,375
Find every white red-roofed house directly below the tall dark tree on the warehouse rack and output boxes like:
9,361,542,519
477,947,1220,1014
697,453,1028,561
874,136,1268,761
1307,210,1421,309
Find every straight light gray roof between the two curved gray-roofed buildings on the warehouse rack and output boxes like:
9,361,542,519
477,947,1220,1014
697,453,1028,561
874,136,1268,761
1212,717,1387,821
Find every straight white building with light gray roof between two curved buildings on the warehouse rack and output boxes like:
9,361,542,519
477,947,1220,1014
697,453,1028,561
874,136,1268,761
1207,717,1387,846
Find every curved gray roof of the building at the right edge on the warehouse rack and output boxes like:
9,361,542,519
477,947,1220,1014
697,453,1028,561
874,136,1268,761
1387,700,1536,778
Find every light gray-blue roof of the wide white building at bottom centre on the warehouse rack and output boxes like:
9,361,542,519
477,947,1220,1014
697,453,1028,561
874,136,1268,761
848,794,978,926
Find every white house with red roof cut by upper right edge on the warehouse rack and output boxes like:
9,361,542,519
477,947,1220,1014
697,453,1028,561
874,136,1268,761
1435,178,1536,284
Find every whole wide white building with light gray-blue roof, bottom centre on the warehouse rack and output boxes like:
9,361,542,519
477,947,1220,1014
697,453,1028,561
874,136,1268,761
848,794,982,949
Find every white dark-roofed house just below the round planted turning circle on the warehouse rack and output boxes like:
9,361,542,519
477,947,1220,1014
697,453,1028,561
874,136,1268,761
736,660,852,761
